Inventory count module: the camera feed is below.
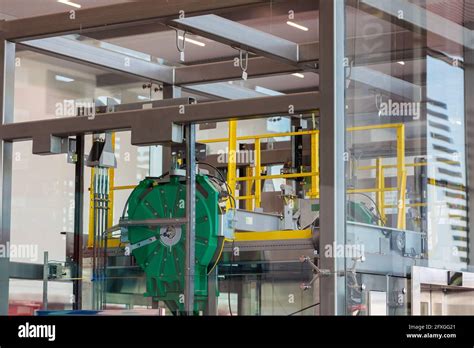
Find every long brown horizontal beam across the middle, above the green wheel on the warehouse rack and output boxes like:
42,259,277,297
0,92,319,146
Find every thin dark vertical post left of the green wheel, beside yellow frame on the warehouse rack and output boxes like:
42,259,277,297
73,135,84,310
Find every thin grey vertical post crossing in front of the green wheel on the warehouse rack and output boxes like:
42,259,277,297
184,124,196,315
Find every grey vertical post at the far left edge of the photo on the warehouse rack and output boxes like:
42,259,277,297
0,38,15,315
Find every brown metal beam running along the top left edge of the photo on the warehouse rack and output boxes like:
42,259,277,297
0,0,268,41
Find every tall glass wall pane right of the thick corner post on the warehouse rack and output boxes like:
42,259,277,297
341,0,474,315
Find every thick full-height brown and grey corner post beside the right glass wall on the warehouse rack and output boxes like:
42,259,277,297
319,0,346,315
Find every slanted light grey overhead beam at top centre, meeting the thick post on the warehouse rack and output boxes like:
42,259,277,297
171,15,299,63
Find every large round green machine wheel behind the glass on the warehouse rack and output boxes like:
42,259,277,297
127,175,224,314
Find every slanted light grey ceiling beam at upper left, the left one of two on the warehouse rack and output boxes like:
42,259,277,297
22,37,173,83
